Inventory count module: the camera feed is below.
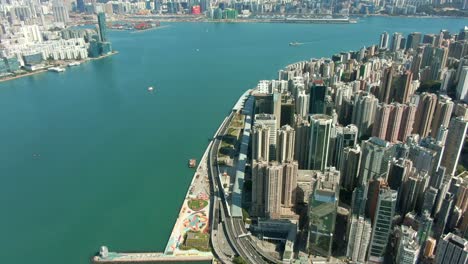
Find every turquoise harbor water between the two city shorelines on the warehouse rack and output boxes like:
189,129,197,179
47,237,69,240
0,18,468,264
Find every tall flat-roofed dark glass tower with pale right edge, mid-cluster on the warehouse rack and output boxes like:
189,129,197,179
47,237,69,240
307,114,333,171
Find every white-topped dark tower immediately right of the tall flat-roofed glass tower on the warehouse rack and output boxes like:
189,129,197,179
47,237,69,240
330,124,358,167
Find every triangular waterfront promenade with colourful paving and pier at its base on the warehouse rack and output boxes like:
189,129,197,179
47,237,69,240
91,136,213,263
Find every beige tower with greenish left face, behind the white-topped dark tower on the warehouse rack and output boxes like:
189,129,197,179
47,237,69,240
351,92,379,139
